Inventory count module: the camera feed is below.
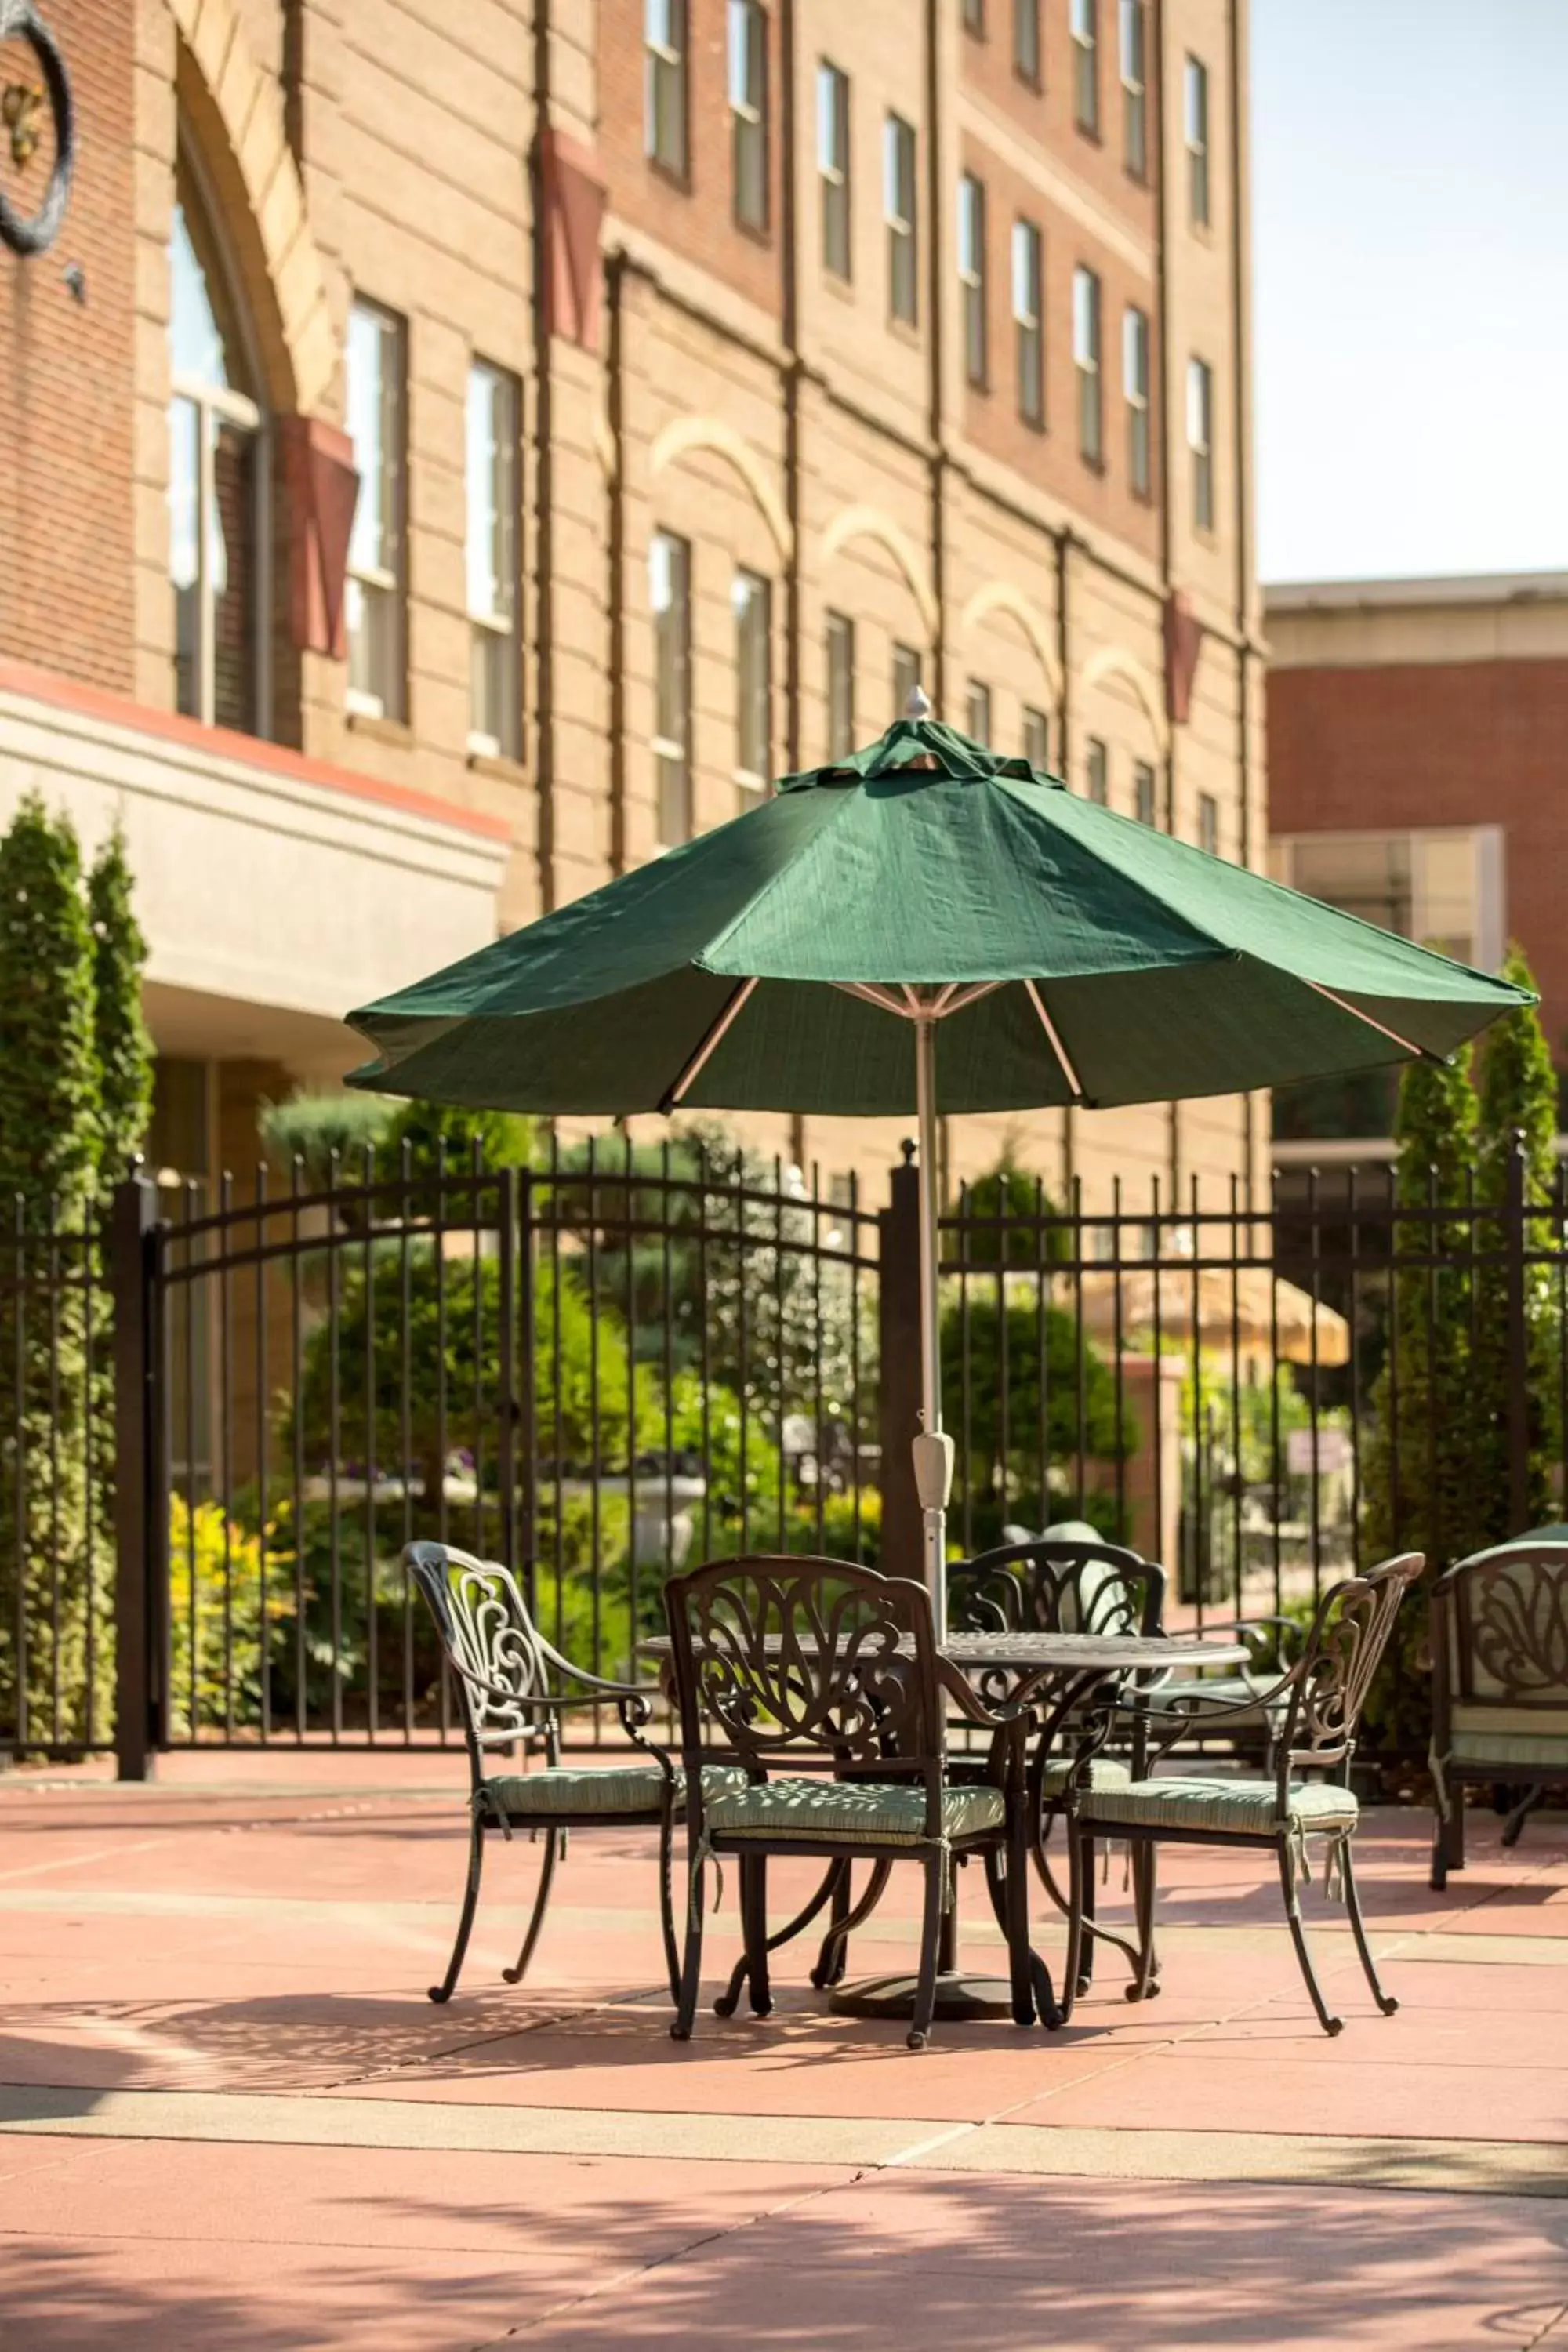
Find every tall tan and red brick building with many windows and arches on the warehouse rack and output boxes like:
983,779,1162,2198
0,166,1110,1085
0,0,1265,1192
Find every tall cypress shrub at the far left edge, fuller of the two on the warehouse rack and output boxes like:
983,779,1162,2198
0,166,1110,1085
0,797,113,1743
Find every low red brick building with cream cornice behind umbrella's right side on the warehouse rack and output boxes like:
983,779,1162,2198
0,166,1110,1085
1265,572,1568,1164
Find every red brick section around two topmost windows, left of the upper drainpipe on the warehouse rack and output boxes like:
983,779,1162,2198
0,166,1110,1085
600,0,780,313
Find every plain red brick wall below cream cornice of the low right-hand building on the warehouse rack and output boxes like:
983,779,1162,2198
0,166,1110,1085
1267,661,1568,1065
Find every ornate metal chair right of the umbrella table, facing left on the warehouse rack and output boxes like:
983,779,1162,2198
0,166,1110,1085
1067,1552,1425,2034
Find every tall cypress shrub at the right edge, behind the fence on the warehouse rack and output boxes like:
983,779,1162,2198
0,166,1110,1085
1472,946,1561,1545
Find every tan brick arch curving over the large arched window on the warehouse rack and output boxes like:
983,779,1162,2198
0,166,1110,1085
169,0,339,416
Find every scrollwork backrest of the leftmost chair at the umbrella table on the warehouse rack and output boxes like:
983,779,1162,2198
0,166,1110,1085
405,1543,557,1773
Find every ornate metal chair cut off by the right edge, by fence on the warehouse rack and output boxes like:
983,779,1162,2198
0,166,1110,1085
1432,1536,1568,1889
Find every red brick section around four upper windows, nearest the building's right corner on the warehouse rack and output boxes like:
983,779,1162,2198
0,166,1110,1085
954,129,1159,557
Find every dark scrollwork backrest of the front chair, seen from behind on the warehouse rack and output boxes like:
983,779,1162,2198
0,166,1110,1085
666,1557,942,1778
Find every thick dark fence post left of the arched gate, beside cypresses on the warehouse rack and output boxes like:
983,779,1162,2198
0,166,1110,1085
108,1176,169,1780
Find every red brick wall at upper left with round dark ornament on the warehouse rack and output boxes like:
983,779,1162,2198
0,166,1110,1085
0,0,134,694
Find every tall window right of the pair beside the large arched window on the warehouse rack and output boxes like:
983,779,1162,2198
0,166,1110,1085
466,360,522,760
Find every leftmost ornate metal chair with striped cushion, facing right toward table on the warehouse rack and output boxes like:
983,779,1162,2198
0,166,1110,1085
405,1543,746,2002
